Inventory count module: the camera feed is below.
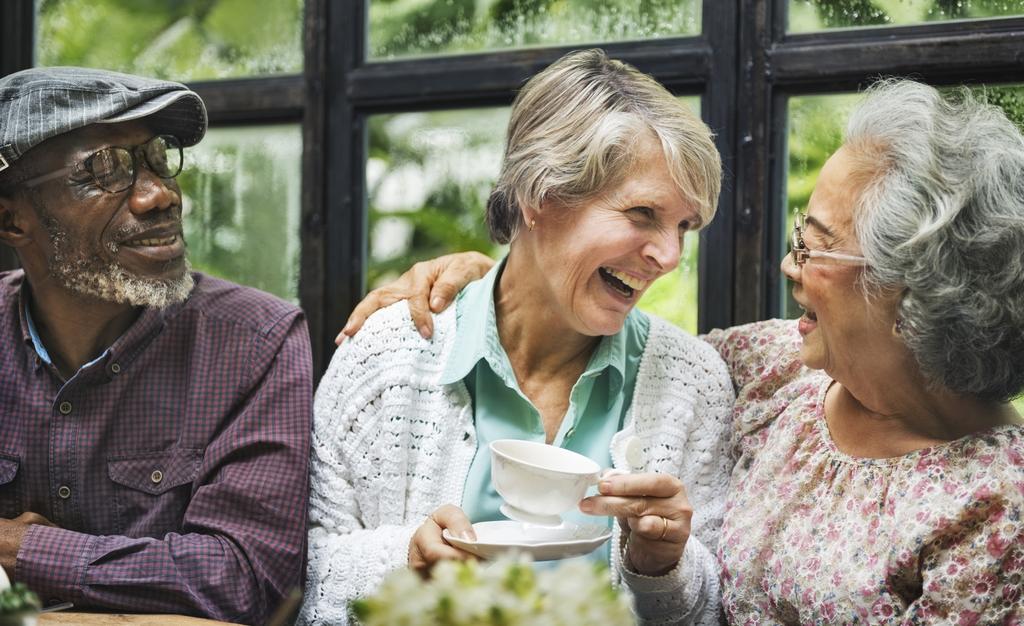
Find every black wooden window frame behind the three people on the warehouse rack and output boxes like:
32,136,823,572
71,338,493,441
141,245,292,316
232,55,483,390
0,0,1024,372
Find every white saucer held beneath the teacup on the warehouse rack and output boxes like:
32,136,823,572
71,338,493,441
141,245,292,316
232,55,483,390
442,521,611,560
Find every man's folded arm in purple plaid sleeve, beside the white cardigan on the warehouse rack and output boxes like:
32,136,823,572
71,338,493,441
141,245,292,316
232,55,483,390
14,314,312,624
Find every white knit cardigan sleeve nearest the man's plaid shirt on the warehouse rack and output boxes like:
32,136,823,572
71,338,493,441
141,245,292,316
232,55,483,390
300,303,468,626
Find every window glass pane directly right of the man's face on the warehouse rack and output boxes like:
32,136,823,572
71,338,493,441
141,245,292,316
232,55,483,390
178,124,302,303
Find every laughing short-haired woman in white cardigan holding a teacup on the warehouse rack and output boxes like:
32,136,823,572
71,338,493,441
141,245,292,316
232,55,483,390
303,50,734,624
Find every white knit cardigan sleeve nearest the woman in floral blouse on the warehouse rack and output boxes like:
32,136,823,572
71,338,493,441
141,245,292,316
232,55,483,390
617,319,734,626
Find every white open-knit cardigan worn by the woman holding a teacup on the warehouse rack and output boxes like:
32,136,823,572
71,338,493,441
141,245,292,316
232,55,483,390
299,302,734,625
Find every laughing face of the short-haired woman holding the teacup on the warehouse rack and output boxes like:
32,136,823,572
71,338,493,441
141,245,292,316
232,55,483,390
529,135,699,336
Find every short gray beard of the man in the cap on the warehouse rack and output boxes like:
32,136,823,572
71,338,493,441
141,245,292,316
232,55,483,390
43,215,195,308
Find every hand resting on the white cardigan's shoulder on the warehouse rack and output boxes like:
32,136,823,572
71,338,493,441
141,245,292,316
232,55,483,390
334,252,495,345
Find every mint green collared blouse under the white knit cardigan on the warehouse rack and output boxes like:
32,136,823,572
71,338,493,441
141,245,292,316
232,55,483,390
440,260,650,562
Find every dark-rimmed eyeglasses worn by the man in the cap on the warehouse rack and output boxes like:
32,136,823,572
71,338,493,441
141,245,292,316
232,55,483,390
22,135,184,194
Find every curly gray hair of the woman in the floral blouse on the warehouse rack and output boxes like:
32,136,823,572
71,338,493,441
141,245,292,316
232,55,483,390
846,79,1024,402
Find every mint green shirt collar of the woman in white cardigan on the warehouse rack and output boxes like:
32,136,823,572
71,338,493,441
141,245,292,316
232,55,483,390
439,257,637,402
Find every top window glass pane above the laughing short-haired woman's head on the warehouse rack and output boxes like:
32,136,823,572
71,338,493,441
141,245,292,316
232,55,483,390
368,0,700,58
